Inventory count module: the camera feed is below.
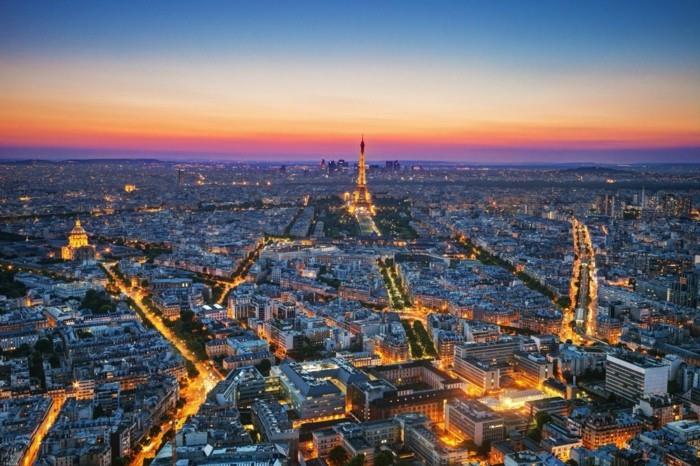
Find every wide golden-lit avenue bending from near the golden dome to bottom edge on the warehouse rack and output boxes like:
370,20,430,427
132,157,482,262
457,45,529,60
105,263,223,466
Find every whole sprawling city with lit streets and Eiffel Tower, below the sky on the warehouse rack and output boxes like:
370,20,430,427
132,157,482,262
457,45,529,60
0,157,700,466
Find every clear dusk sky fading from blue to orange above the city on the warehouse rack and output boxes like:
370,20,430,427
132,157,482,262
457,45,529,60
0,0,700,163
